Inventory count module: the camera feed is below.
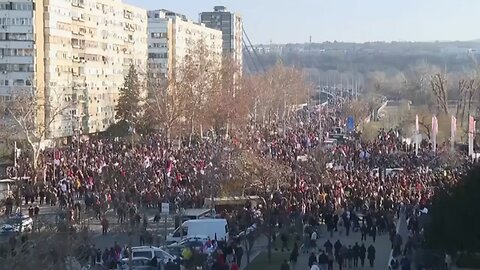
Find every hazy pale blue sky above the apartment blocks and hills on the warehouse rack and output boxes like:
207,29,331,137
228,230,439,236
123,0,480,44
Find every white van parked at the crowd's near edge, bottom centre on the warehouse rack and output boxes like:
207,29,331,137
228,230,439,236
167,219,228,243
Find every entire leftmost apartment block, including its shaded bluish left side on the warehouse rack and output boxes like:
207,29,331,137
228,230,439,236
0,0,147,137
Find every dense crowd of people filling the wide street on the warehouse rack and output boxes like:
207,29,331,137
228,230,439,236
3,97,472,270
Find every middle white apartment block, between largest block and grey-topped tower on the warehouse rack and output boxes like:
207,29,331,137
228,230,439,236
148,10,223,77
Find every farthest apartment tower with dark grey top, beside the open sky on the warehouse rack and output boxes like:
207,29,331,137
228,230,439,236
200,6,243,70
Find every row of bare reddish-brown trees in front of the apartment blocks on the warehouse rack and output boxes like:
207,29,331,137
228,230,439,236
115,43,310,141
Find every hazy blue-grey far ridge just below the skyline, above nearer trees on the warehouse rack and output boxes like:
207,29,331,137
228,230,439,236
246,40,480,74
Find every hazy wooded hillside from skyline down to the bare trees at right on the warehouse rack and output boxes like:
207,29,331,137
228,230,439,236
244,41,480,104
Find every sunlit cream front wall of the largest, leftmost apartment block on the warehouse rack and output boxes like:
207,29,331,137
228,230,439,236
45,0,147,137
